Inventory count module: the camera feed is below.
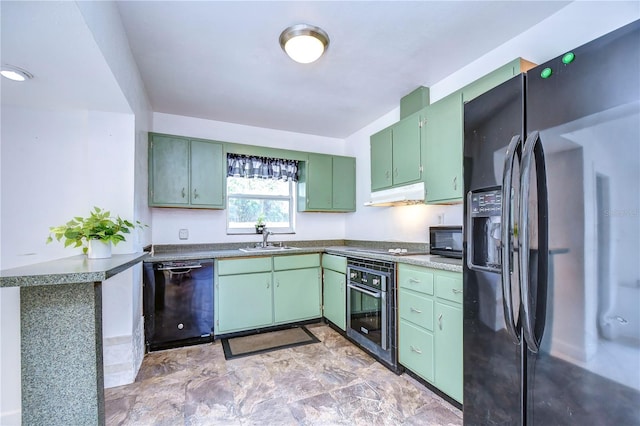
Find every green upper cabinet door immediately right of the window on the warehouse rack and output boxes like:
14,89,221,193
307,154,333,210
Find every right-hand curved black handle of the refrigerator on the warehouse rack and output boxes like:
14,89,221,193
519,131,549,353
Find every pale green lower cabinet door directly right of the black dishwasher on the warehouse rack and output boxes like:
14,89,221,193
216,272,273,334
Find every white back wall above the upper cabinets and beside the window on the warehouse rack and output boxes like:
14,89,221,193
152,113,350,244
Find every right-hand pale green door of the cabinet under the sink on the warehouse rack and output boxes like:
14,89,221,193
273,268,322,323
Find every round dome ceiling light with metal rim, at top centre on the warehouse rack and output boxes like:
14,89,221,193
280,24,329,64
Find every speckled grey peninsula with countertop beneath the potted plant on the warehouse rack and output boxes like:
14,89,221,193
0,253,147,424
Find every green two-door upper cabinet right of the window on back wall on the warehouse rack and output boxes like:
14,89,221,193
298,153,356,212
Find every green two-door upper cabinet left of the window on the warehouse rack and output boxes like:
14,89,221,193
149,133,226,209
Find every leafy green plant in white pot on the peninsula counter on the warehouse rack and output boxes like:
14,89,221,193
47,207,146,259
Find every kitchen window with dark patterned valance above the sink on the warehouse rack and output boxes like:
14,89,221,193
227,154,297,234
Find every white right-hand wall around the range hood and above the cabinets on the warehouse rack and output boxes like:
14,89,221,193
345,1,640,242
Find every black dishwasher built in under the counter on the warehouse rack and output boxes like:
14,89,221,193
143,259,213,351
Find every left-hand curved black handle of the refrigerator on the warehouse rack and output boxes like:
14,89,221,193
500,135,522,344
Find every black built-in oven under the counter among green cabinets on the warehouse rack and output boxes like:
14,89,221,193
347,257,399,373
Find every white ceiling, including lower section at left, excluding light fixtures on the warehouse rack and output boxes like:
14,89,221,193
1,0,567,138
